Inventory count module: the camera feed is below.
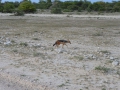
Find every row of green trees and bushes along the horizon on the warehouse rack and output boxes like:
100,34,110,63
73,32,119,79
0,0,120,13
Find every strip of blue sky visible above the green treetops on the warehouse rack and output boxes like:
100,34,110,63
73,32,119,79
2,0,119,2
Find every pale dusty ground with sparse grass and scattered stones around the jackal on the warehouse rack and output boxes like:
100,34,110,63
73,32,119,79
0,14,120,90
